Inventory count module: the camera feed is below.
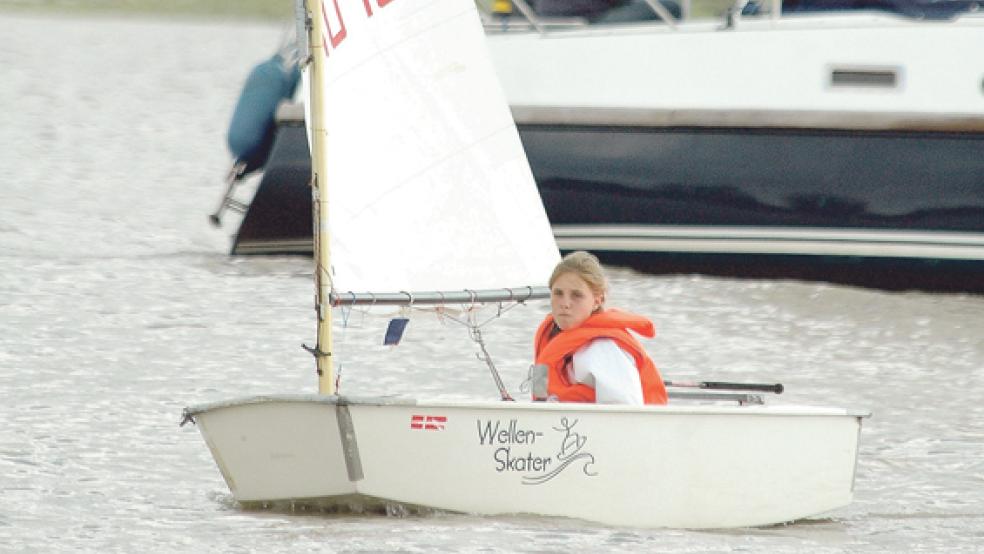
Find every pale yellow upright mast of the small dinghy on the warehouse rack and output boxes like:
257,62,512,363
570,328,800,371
305,0,335,394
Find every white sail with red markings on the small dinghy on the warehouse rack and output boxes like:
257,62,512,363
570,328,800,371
311,0,558,294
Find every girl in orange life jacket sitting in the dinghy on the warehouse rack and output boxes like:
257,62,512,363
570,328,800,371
534,251,666,405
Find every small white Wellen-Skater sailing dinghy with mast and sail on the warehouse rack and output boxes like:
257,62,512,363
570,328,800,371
185,0,867,528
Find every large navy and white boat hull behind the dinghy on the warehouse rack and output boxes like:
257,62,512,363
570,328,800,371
209,0,984,292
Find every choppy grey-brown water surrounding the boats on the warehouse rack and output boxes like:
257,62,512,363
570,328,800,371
0,10,984,552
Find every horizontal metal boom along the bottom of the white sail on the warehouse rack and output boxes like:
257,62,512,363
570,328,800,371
330,286,550,307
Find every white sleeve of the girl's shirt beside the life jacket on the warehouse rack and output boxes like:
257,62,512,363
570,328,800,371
570,338,643,406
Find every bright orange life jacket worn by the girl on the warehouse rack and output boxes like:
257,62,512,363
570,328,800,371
534,309,666,404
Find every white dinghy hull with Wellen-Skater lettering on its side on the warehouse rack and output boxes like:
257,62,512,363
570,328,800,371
186,395,867,529
